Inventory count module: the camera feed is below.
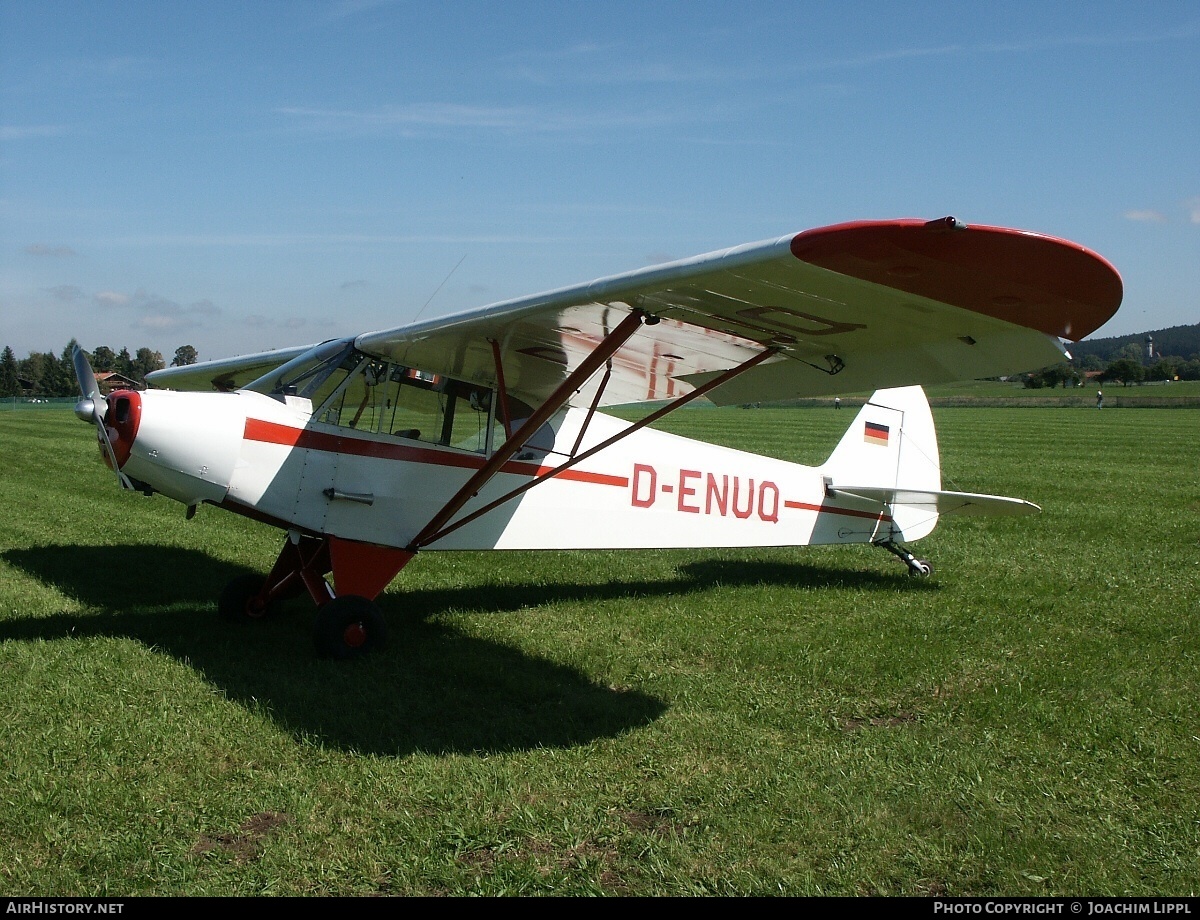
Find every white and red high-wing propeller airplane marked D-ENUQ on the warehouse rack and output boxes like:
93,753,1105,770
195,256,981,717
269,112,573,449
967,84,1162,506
74,217,1123,660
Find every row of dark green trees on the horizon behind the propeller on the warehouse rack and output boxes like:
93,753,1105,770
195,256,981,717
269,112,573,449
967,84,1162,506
0,338,197,398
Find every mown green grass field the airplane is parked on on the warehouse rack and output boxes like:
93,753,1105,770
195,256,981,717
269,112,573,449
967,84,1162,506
0,407,1200,897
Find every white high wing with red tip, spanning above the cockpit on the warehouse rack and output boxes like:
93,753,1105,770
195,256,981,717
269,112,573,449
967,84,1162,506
148,217,1122,407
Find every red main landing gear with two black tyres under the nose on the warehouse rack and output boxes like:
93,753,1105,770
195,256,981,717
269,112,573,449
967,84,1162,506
217,534,413,661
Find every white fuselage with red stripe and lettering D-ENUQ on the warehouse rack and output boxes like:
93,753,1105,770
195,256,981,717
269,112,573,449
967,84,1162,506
110,390,907,549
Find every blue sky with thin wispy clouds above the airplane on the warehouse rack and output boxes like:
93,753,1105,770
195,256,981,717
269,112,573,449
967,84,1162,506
0,0,1200,362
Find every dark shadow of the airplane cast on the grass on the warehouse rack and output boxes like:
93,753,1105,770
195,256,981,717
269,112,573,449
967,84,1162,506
0,545,936,756
